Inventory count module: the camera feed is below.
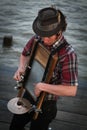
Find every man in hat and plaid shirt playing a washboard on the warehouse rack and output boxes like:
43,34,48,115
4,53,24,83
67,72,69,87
10,7,78,130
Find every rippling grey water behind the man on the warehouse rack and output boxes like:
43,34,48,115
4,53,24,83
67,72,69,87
0,0,87,85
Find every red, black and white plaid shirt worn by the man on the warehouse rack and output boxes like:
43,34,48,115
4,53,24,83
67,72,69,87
22,36,78,100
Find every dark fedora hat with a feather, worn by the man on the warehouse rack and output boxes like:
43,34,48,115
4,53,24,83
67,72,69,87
32,7,61,37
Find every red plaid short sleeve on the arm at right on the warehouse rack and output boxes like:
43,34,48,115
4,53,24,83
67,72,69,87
61,52,78,86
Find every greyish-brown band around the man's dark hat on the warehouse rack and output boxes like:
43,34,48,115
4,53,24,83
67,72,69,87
37,22,58,31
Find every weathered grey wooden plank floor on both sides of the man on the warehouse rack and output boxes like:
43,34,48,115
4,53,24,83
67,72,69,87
0,65,87,130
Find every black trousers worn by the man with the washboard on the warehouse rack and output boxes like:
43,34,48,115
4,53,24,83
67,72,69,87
9,100,57,130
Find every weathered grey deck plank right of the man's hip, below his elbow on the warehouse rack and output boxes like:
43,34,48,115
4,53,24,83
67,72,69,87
57,89,87,115
